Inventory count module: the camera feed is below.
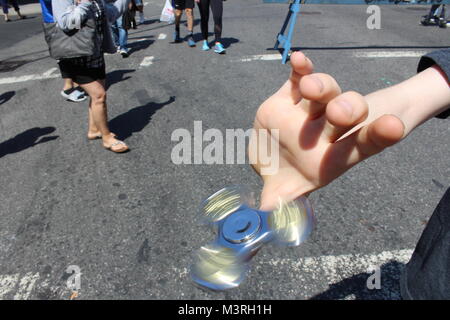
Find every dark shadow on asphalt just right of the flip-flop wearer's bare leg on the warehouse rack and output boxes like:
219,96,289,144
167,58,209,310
109,96,175,140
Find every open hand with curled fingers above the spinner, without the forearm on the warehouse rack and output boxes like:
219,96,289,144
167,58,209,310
249,52,404,210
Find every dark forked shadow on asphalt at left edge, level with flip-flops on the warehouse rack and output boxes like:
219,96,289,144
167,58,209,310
0,127,59,158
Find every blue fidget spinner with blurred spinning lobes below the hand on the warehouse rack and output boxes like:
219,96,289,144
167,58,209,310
191,186,315,291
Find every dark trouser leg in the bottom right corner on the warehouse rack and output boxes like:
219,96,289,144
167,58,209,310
401,188,450,300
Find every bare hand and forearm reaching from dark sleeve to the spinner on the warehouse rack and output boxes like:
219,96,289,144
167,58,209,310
249,52,450,210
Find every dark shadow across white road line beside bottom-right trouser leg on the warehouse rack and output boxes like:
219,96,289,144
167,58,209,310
311,261,405,300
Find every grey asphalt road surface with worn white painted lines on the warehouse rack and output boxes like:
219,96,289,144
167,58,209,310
0,0,450,299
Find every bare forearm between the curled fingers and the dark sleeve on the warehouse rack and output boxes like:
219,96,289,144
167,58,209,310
363,65,450,137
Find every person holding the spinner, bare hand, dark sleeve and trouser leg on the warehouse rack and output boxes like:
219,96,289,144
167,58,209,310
249,49,450,299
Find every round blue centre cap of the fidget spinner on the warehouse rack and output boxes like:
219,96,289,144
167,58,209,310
222,210,261,243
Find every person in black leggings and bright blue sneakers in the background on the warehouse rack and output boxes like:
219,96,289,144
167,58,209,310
195,0,225,54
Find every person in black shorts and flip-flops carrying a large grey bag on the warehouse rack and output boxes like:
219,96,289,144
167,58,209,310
52,0,129,153
